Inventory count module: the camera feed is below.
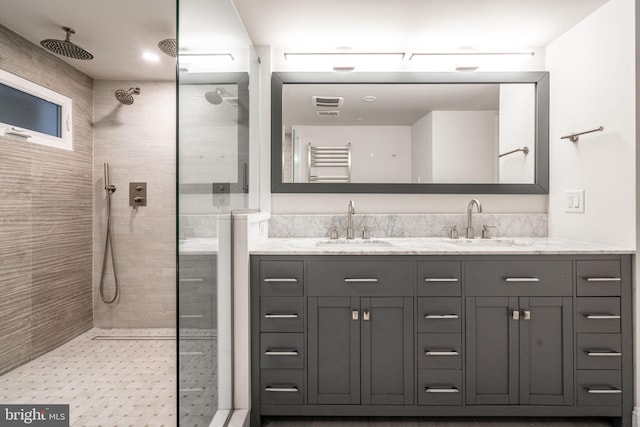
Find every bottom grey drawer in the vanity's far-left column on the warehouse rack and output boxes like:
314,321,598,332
260,369,304,405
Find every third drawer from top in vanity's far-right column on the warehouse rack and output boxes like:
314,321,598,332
577,334,622,369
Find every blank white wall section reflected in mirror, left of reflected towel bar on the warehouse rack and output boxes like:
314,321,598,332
431,111,498,184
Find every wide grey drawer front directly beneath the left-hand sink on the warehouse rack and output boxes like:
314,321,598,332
307,259,415,297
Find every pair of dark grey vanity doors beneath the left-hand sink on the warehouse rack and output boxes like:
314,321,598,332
308,297,414,405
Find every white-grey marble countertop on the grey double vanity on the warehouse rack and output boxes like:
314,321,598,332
249,237,635,255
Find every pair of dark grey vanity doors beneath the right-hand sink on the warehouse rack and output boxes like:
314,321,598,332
466,297,573,405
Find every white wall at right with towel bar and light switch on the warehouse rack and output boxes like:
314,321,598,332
547,0,636,248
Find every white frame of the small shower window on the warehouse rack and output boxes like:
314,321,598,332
0,69,73,151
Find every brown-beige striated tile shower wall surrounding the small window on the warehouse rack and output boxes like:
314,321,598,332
0,25,93,374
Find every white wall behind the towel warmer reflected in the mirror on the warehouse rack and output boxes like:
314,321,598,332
294,126,411,183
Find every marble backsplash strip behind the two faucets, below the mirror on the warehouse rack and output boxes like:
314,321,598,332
269,213,548,238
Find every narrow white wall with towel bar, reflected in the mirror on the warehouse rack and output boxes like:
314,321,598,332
498,84,536,183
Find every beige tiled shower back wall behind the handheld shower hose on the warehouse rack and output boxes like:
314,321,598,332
93,80,176,328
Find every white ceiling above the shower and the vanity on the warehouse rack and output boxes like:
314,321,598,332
0,0,606,80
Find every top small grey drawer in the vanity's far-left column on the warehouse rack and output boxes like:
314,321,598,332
260,261,304,296
